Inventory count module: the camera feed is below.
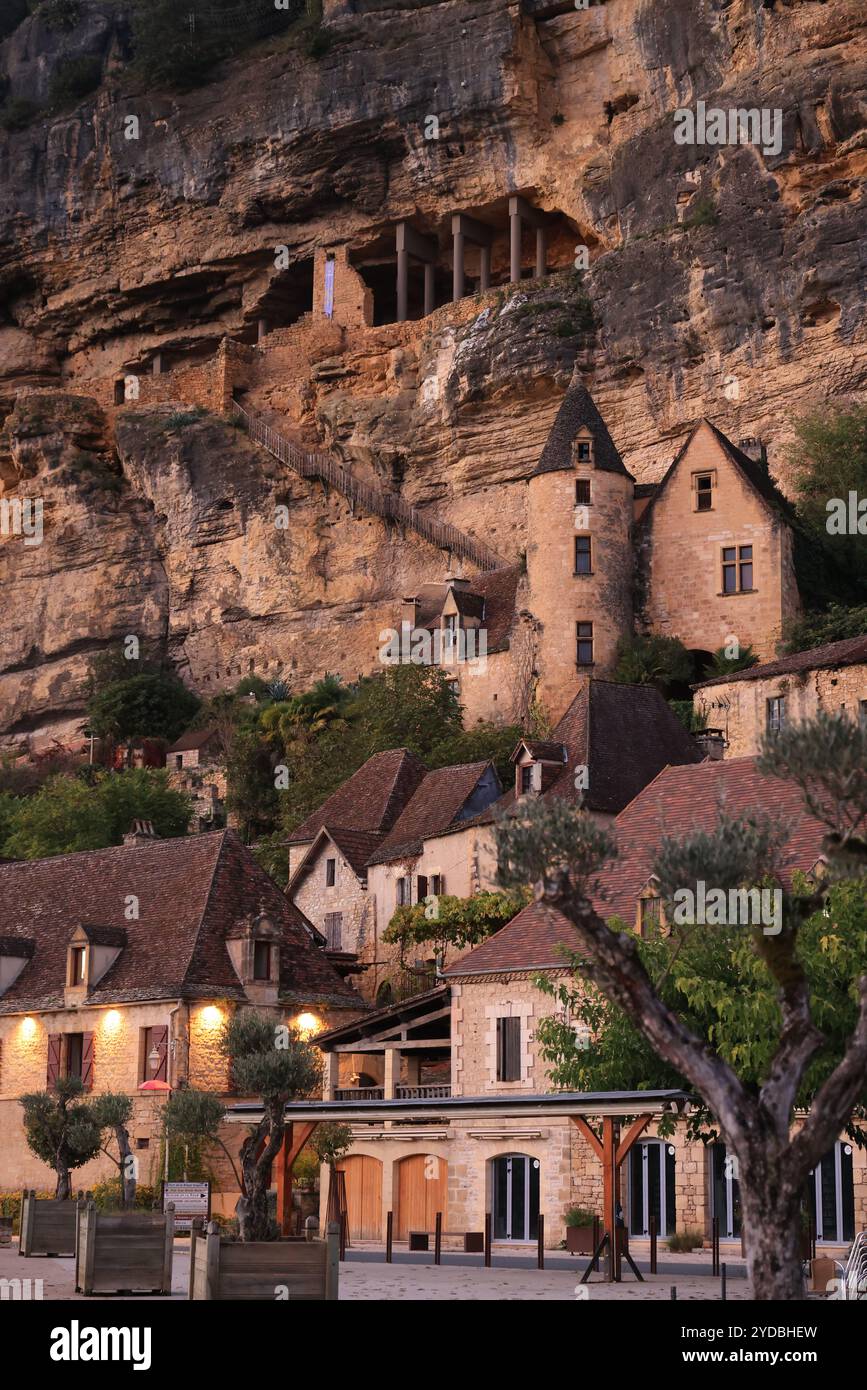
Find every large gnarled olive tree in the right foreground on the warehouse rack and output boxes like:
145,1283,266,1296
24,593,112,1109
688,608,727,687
496,716,867,1300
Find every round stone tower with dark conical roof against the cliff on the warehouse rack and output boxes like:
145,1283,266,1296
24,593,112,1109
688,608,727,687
527,375,635,717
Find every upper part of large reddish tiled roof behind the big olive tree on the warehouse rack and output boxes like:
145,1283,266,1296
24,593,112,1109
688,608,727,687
596,758,824,924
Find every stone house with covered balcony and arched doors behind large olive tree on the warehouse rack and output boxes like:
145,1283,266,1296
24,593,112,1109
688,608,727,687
280,759,867,1247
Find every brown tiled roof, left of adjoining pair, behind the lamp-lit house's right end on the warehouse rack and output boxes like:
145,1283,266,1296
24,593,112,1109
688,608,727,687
288,748,425,845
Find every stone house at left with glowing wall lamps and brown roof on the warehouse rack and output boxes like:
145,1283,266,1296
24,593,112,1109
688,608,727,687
0,830,364,1212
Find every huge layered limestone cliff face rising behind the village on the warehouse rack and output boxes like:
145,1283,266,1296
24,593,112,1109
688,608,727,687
0,0,867,734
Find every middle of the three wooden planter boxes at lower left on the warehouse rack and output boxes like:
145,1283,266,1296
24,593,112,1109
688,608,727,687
75,1202,175,1294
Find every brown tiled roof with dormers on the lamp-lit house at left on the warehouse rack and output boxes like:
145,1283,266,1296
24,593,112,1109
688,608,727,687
0,830,364,1013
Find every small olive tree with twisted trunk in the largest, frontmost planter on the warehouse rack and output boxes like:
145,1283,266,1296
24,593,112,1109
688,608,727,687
220,1009,321,1240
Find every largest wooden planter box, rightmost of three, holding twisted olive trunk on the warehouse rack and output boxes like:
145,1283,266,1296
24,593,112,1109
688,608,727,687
189,1222,340,1302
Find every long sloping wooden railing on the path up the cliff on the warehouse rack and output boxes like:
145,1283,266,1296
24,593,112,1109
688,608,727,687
232,400,506,570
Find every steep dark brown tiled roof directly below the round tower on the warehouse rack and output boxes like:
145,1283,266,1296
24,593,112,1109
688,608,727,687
464,680,704,823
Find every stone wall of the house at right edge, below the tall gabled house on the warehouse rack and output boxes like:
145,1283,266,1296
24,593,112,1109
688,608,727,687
693,662,867,758
